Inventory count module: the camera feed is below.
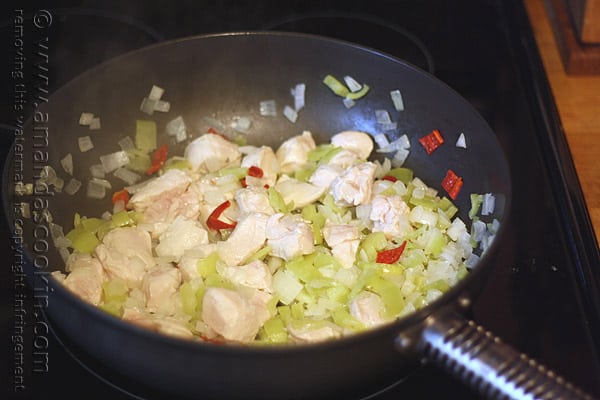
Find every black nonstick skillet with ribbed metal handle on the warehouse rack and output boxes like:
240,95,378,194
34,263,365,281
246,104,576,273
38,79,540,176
4,32,585,399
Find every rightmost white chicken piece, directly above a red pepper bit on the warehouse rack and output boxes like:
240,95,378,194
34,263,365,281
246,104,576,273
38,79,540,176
369,195,413,238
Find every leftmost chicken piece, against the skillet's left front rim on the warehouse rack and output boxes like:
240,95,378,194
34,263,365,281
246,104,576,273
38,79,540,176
63,253,106,306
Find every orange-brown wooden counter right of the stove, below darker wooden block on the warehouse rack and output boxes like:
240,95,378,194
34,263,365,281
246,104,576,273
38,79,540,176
525,0,600,247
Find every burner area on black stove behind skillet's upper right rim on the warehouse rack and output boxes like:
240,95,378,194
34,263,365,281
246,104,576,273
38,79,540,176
261,12,435,74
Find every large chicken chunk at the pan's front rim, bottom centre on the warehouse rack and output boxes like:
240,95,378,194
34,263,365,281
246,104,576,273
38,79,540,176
202,287,270,342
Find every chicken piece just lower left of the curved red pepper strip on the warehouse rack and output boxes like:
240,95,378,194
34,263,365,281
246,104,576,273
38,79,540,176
155,216,208,262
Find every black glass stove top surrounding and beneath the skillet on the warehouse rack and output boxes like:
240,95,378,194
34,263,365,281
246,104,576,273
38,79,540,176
0,0,600,399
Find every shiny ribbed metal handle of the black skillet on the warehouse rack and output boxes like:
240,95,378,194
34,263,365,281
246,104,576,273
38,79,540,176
408,313,592,400
